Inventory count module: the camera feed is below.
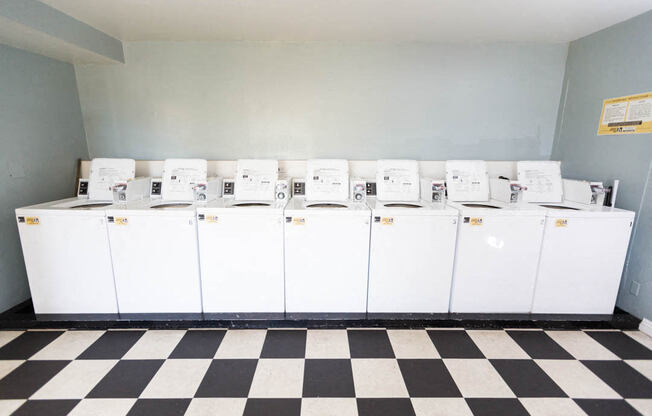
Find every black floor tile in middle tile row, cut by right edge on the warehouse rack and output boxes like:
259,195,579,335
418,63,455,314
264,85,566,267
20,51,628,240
582,361,652,399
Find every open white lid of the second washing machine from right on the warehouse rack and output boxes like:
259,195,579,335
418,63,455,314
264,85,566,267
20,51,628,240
446,160,489,201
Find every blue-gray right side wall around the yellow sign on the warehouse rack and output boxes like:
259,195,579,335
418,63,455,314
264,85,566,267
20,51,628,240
552,12,652,319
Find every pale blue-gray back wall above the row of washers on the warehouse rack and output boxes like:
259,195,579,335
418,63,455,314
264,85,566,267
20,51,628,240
75,42,567,160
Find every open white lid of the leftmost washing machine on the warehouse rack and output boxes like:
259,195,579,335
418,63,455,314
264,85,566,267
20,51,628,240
88,158,136,200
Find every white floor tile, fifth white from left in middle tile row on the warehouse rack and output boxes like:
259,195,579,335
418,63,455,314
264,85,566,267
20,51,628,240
444,359,515,398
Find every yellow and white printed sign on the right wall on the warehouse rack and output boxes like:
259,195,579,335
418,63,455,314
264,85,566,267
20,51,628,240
598,92,652,136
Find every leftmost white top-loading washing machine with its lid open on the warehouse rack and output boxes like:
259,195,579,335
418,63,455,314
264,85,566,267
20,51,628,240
16,159,149,314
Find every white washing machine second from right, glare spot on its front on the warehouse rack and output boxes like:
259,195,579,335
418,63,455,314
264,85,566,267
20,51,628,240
446,161,545,313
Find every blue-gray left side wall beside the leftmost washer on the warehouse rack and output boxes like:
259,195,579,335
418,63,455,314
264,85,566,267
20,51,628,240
0,45,88,311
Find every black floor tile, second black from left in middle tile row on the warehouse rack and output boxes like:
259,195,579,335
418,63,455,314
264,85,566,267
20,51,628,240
86,360,164,399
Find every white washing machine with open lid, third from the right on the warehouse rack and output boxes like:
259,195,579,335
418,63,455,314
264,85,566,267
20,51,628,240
367,160,458,313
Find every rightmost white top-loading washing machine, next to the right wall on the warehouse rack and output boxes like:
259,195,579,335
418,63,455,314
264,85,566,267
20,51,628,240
518,162,635,314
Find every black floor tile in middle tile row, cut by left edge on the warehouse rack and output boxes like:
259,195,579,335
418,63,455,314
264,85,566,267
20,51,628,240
0,361,70,399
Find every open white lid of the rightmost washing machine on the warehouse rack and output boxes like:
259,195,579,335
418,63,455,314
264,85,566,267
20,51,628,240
516,160,563,202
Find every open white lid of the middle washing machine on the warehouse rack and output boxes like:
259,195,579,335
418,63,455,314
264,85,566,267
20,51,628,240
305,159,349,201
